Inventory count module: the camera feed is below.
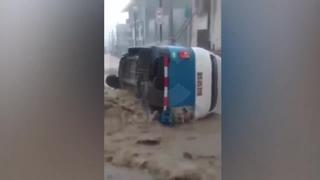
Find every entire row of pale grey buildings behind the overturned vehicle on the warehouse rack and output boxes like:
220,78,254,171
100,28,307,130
119,0,221,54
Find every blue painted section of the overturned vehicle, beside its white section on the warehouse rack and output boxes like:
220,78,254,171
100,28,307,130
168,47,195,107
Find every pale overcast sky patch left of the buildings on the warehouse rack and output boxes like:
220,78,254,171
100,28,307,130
104,0,130,39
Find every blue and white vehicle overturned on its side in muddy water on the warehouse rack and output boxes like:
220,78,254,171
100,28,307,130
106,46,221,125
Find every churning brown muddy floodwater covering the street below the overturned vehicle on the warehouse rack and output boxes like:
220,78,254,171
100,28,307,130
104,87,221,180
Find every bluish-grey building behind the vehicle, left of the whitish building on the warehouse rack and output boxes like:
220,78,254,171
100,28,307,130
124,0,191,46
